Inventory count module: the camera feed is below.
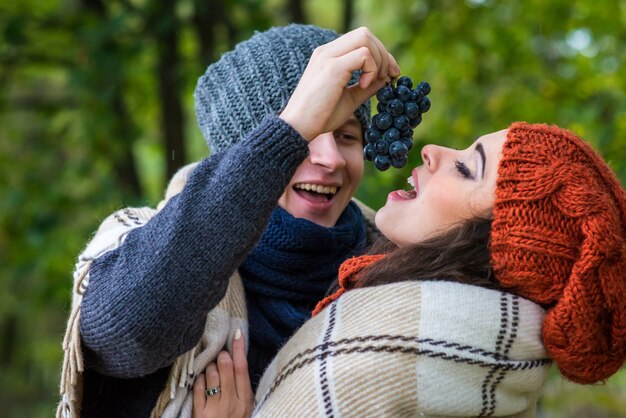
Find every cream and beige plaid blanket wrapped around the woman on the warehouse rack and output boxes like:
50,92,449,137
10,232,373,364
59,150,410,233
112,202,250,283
254,281,551,418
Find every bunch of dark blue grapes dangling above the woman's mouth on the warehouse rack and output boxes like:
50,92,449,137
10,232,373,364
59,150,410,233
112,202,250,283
363,76,430,171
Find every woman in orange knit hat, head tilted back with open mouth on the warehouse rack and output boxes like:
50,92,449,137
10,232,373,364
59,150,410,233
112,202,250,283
194,123,626,417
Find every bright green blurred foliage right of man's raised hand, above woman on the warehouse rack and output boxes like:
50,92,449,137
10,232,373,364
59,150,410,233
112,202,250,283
359,0,626,207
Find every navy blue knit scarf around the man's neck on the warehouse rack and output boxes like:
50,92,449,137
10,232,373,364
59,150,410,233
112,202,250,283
239,202,366,355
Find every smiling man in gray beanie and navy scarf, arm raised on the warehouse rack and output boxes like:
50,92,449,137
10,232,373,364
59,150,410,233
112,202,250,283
57,25,399,417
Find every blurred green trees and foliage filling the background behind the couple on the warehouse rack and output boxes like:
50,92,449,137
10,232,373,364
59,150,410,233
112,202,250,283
0,0,626,417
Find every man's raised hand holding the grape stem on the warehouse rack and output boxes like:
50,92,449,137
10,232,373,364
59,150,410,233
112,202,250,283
280,27,400,141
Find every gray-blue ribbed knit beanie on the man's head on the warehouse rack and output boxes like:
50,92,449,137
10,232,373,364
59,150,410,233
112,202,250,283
194,24,370,153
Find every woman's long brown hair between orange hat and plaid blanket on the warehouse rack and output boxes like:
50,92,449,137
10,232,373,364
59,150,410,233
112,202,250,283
355,218,500,289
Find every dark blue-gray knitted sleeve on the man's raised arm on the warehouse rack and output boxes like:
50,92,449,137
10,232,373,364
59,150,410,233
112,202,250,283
80,116,308,378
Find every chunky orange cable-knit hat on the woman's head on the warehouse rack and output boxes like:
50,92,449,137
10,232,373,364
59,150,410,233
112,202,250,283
490,122,626,383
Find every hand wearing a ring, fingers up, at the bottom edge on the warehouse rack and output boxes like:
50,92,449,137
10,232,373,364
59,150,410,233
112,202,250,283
193,330,254,418
